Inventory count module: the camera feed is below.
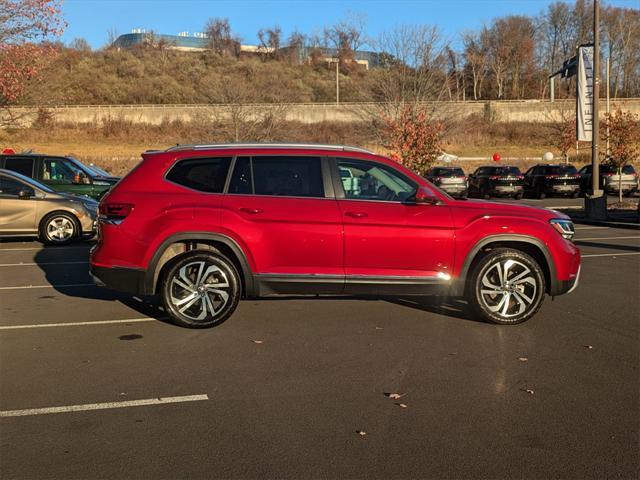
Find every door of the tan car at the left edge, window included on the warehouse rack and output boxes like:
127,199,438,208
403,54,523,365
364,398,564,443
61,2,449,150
0,175,38,235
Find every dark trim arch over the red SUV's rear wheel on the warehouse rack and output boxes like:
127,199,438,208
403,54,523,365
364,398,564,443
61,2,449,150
144,232,256,297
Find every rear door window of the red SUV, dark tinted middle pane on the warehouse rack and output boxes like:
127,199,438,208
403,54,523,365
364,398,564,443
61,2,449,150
229,156,324,197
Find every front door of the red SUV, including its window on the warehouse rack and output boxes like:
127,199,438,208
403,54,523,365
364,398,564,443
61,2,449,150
333,158,454,293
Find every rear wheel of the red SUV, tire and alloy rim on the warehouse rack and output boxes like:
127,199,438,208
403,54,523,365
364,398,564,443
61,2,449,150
159,250,242,328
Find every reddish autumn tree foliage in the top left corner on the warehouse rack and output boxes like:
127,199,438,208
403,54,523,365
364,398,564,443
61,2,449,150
0,0,64,105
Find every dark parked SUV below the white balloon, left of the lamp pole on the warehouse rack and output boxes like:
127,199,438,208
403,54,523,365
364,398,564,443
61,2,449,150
524,165,580,198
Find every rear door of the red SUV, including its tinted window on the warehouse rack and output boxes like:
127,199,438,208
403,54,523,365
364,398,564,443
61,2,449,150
222,155,350,293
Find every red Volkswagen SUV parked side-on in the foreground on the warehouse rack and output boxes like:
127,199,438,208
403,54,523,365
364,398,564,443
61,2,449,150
91,144,580,328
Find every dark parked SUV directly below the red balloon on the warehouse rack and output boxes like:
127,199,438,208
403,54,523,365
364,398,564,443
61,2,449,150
469,165,524,200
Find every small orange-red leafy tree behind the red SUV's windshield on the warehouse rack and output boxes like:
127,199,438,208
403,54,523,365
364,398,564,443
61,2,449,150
384,105,444,175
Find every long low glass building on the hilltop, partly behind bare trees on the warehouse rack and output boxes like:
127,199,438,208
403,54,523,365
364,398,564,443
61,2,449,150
113,29,380,70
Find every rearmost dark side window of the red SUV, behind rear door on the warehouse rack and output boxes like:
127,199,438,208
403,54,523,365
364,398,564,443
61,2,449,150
166,157,231,193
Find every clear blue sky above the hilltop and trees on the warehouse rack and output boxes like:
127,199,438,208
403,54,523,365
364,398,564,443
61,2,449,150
62,0,639,48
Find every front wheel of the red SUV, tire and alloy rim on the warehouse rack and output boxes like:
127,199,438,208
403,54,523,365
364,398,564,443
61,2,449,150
466,248,546,325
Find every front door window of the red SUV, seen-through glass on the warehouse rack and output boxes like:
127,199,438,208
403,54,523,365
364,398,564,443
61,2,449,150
338,159,417,202
